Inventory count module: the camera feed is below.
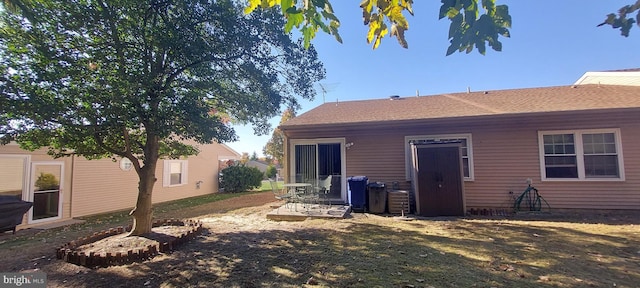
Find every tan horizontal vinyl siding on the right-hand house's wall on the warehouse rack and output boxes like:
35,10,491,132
285,111,640,209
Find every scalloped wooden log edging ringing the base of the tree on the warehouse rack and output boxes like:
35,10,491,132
56,219,204,268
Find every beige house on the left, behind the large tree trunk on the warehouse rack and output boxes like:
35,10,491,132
0,143,240,228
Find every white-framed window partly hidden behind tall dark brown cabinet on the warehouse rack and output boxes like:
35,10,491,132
404,134,473,181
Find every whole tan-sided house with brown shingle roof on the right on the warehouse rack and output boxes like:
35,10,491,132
280,70,640,216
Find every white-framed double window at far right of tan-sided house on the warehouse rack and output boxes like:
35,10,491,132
539,129,624,180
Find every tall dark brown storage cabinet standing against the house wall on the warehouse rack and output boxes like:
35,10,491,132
414,144,464,217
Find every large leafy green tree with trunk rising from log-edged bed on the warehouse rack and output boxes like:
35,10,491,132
0,0,324,235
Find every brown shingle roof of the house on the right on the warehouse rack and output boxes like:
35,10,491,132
281,85,640,129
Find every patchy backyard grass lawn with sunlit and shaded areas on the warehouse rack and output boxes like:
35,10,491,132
0,192,640,287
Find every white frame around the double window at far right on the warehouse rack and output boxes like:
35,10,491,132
538,128,625,182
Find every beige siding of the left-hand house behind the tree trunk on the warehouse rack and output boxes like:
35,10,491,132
0,143,232,228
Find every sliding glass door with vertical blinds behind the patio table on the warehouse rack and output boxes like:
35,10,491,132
290,139,345,201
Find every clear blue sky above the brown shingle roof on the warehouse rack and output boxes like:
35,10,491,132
227,0,640,155
